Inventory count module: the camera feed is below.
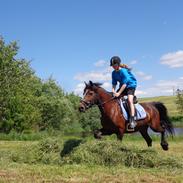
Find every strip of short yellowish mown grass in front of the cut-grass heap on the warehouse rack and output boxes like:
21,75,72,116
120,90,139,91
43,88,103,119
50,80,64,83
0,164,183,183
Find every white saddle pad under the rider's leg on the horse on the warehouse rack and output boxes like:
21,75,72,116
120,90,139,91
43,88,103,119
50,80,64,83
120,100,147,121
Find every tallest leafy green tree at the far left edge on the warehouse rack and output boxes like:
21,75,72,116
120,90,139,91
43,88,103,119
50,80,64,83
0,38,41,132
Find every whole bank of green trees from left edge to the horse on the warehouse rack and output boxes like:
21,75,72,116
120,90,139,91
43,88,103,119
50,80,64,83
0,38,100,133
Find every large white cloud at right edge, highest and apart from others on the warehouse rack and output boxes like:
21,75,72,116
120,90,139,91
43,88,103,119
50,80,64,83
160,50,183,68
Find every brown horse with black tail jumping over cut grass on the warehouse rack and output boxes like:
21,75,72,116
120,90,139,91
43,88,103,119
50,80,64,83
79,81,174,150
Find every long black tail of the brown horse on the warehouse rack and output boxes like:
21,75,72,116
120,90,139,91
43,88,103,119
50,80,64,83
153,102,175,136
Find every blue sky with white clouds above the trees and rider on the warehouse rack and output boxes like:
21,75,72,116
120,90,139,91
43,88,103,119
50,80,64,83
0,0,183,97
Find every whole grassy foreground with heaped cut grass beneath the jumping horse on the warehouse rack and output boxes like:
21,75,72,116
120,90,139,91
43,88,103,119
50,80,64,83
0,135,183,183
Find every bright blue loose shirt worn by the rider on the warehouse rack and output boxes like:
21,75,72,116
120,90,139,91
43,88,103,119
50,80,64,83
112,68,137,88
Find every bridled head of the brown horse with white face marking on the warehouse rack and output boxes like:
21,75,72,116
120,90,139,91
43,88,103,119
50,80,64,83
79,81,100,112
